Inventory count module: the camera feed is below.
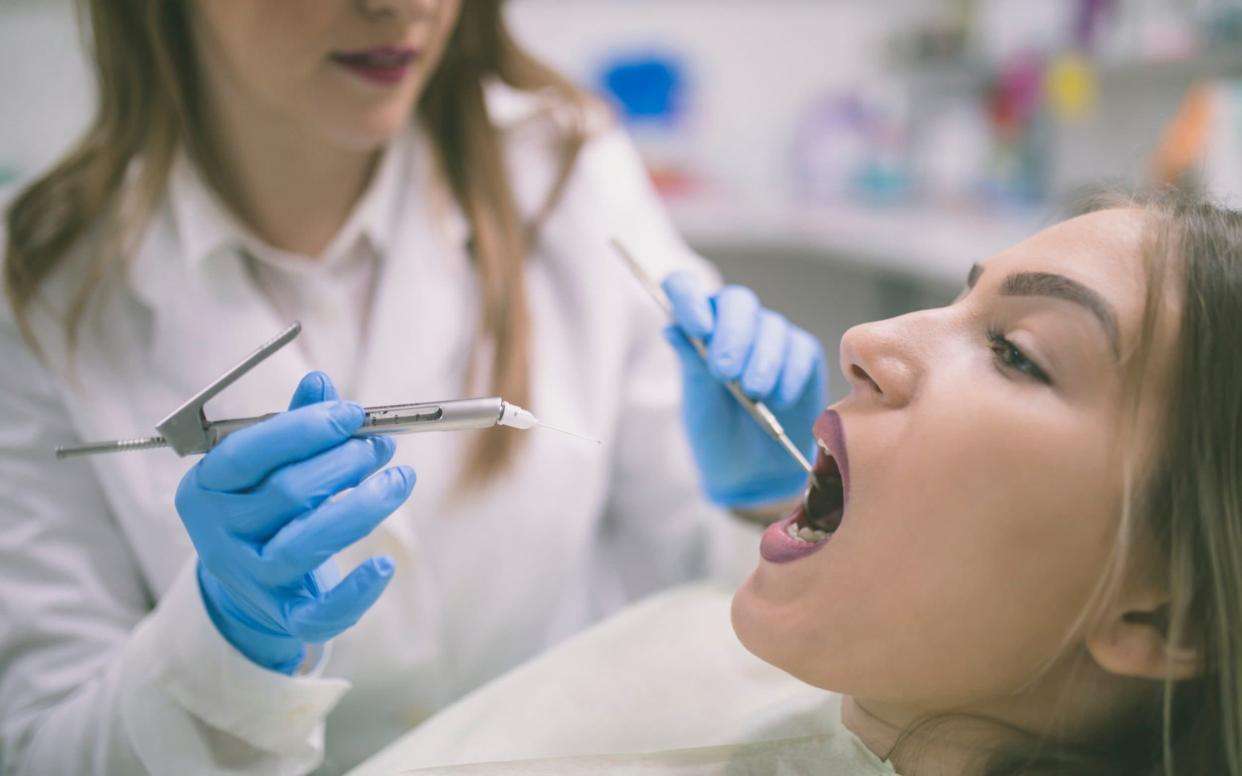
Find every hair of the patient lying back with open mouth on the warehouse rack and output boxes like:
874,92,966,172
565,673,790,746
889,190,1242,776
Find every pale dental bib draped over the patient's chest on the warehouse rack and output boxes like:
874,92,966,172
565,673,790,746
353,585,897,776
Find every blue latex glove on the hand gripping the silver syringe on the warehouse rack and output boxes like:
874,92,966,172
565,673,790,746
176,372,415,673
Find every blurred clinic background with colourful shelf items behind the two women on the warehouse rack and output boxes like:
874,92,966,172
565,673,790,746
0,0,1242,369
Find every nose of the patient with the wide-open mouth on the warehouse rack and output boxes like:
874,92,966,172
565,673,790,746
841,314,923,408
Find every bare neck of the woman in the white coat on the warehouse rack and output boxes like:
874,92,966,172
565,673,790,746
193,64,379,257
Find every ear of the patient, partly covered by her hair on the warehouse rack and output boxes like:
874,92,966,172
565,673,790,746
1087,596,1202,679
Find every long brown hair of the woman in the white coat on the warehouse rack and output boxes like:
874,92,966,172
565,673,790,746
4,0,595,485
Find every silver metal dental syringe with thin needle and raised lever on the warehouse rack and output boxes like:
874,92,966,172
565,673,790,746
56,322,586,459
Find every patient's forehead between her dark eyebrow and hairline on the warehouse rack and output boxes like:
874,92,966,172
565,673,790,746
981,209,1153,343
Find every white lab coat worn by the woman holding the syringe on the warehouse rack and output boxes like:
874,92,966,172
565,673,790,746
0,91,753,775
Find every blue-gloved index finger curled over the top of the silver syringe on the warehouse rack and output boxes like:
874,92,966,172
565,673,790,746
197,401,365,490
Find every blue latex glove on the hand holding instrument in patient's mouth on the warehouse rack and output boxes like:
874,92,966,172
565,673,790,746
663,272,827,509
